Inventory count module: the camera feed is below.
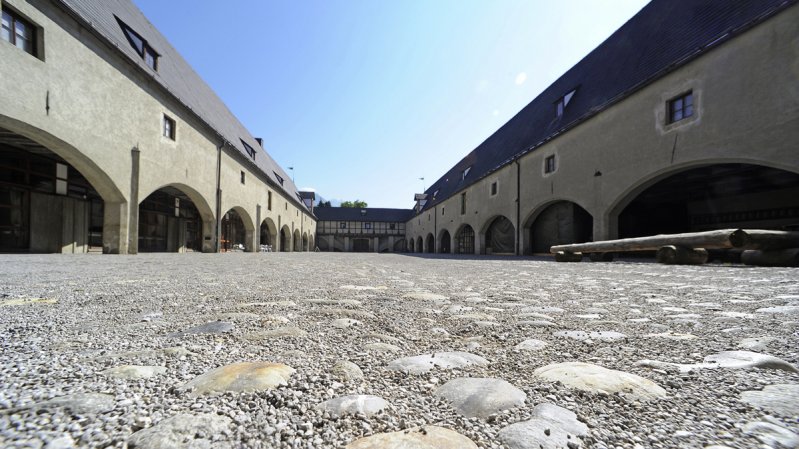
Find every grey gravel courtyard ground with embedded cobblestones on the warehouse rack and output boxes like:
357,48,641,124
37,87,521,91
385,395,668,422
0,253,799,448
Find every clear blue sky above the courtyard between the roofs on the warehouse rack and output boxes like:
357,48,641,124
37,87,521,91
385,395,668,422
134,0,647,208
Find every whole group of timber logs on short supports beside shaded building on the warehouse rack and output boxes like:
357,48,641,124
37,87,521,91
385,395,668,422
549,229,799,267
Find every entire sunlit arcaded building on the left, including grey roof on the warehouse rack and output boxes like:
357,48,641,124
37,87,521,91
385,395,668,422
0,0,316,254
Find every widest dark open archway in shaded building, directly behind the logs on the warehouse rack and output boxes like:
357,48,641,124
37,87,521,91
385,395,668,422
610,163,799,238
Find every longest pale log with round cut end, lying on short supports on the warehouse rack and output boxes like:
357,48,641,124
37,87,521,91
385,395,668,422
549,229,748,254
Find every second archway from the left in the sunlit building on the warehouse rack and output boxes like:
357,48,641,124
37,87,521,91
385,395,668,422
139,183,215,253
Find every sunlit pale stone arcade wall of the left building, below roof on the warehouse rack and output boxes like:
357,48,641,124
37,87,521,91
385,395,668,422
0,0,315,253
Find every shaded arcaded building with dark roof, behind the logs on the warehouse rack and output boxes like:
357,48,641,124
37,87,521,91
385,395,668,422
406,0,799,254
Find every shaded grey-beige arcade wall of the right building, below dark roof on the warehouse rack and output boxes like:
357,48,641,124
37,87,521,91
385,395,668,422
406,7,799,253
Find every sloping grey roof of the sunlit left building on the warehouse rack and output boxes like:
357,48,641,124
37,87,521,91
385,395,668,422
54,0,307,209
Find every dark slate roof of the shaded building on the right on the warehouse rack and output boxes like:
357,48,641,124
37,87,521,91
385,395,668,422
422,0,796,214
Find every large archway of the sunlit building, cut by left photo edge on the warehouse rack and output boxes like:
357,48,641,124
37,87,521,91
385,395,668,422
0,119,129,253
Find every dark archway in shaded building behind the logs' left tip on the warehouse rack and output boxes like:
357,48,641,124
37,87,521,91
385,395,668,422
524,200,594,254
